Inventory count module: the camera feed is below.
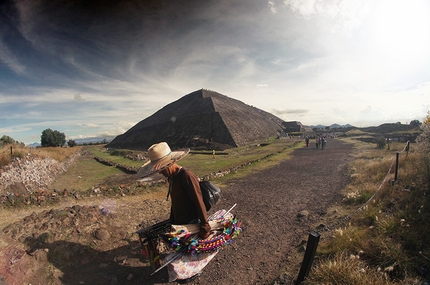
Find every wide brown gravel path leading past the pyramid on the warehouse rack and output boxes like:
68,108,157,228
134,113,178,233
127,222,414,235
145,139,352,284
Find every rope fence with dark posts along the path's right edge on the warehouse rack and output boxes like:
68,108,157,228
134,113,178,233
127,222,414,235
296,141,410,285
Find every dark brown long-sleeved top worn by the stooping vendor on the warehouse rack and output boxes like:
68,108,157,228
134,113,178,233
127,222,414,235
169,168,210,234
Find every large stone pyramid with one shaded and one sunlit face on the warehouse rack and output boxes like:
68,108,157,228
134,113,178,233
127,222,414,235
107,89,284,150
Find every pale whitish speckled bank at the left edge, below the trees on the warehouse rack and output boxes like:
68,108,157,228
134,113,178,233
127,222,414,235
0,153,80,195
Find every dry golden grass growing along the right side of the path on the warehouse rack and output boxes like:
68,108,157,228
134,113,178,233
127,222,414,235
304,139,430,285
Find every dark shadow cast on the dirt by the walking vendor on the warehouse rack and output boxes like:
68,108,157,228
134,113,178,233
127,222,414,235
26,234,168,285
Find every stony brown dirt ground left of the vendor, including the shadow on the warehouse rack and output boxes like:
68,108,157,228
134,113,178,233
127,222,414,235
0,194,169,284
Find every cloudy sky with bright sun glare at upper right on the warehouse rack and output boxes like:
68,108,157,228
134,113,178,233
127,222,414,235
0,0,430,144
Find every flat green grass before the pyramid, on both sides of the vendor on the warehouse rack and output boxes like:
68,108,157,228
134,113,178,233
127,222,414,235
47,138,303,192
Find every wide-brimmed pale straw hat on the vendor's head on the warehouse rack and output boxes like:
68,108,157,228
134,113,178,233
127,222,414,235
137,142,190,177
